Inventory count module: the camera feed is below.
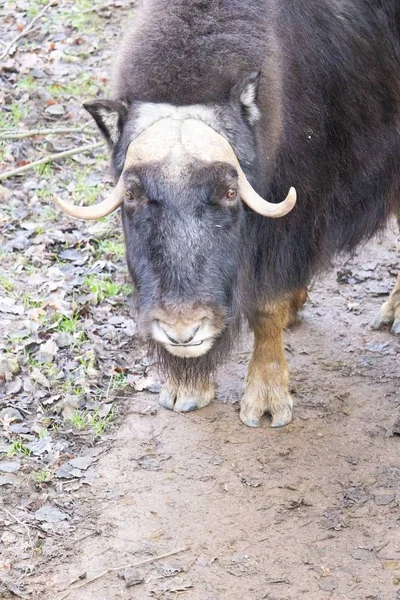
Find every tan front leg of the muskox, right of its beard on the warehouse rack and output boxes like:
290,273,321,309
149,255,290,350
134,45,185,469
240,298,293,427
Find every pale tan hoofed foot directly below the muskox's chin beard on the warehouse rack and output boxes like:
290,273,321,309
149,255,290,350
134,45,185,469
159,380,215,412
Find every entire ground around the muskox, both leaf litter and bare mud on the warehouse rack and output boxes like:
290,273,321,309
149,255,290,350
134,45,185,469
0,0,400,600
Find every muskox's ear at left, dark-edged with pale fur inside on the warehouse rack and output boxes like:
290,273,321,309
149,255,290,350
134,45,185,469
83,100,128,148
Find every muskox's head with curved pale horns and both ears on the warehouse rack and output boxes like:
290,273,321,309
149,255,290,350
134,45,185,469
53,78,296,376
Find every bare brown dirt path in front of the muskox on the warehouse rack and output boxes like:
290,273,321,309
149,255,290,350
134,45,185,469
36,229,400,600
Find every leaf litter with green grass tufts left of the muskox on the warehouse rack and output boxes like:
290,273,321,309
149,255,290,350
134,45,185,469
0,0,159,598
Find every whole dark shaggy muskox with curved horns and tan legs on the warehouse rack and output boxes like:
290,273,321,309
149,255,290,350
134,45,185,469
53,0,400,427
